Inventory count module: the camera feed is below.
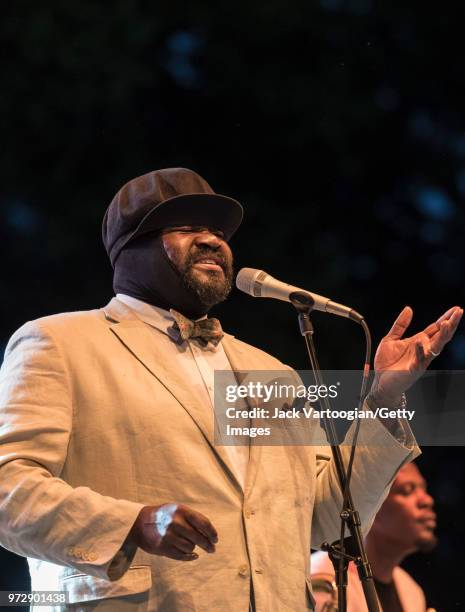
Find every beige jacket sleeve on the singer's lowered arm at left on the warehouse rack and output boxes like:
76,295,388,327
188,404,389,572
0,320,142,580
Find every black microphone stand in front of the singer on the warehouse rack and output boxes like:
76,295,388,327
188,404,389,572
290,292,380,612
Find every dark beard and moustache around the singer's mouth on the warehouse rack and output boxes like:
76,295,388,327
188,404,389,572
179,246,234,309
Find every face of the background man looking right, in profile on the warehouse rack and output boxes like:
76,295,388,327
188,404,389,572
371,463,436,554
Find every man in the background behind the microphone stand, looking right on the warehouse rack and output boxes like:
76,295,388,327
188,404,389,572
311,463,437,612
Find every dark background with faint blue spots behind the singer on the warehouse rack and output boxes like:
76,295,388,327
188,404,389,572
0,0,465,611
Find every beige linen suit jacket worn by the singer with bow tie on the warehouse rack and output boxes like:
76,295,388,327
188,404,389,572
0,299,412,612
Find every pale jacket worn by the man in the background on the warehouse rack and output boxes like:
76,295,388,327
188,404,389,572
311,552,426,612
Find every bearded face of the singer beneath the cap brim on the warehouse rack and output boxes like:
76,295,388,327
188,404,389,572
162,226,233,308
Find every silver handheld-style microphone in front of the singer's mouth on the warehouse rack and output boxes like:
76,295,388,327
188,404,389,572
236,268,363,323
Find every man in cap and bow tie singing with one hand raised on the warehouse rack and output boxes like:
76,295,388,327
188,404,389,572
0,168,462,612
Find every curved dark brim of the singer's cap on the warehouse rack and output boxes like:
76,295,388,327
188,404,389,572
130,193,244,240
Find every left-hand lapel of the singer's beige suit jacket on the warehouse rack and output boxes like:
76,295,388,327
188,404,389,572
103,298,242,490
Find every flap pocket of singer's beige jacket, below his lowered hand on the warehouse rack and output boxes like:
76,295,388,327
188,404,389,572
60,565,152,604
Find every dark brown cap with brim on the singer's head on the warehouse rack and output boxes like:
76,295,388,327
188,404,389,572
102,168,243,265
